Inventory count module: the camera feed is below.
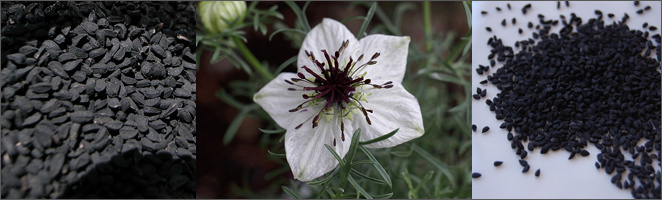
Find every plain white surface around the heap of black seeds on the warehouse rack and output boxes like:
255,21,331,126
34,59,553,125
472,1,661,199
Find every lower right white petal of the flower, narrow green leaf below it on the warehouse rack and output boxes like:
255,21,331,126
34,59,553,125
353,84,425,148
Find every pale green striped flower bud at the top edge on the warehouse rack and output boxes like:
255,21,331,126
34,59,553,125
198,1,246,34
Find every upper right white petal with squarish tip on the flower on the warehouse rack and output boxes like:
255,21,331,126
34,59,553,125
357,34,410,84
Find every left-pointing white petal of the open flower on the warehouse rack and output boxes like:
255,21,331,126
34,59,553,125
253,73,323,129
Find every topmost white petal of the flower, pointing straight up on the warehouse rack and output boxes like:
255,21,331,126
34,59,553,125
297,18,361,77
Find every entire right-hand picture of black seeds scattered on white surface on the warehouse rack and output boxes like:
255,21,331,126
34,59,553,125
472,2,662,199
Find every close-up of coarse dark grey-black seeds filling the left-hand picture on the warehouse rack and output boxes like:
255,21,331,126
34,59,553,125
0,1,196,199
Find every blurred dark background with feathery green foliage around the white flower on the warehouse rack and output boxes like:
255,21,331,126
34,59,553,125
196,2,471,198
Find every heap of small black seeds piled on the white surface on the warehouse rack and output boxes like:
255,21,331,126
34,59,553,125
477,4,662,199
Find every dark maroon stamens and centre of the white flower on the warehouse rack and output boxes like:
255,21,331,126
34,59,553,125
285,40,393,146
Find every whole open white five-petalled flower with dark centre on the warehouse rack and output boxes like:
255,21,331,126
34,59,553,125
253,19,424,181
